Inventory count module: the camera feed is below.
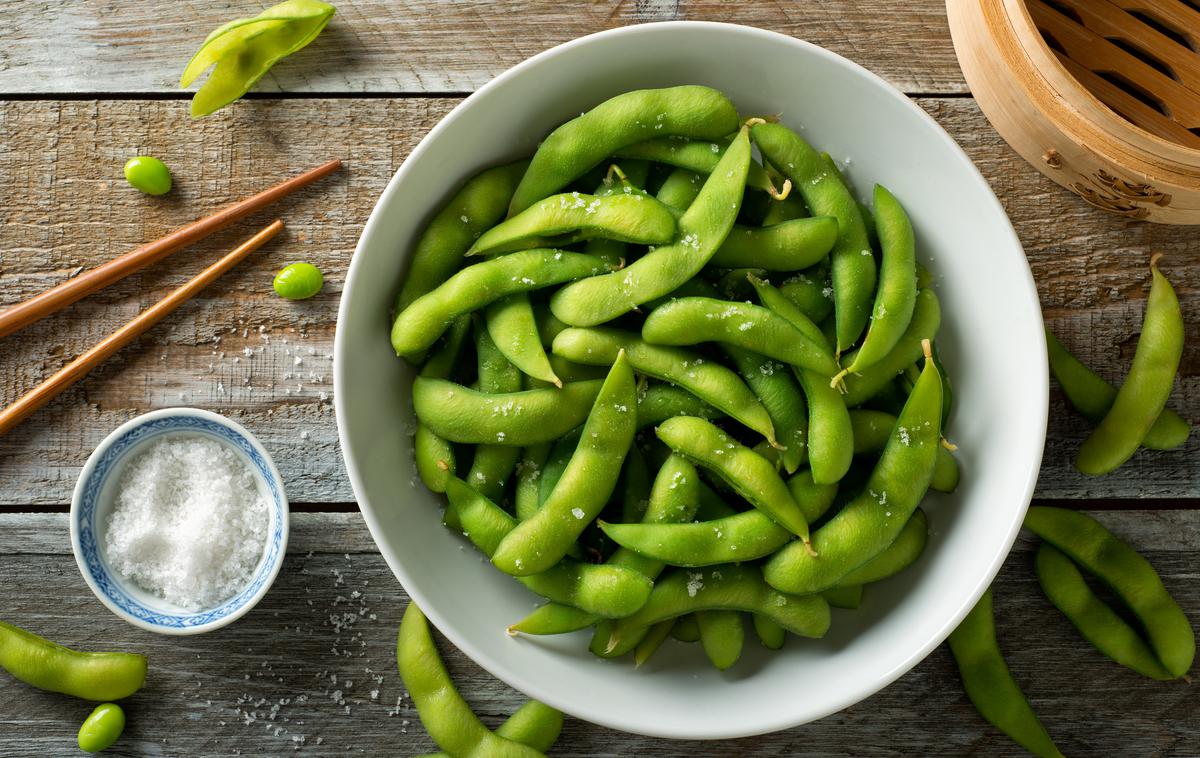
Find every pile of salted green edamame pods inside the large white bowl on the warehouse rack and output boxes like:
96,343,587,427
391,86,959,668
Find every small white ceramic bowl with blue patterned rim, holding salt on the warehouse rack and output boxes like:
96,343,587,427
71,408,288,634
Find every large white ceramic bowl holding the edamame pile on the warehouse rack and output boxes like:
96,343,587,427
335,22,1048,739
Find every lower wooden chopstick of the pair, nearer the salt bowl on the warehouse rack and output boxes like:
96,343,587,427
0,221,283,435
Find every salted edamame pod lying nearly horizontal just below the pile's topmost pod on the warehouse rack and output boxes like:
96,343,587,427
467,192,676,255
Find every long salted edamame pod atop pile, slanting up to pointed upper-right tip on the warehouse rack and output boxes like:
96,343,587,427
549,128,750,326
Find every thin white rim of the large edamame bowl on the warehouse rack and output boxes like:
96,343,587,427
334,20,1049,740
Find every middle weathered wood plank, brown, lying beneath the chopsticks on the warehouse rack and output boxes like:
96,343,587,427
0,98,1200,505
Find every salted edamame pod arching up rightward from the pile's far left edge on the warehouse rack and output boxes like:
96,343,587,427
391,249,605,360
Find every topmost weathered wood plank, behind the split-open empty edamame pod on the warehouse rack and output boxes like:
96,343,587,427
0,0,966,95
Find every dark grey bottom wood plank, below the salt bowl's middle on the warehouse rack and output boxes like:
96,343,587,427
0,512,1200,758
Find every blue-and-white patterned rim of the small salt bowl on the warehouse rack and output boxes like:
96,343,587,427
70,407,290,636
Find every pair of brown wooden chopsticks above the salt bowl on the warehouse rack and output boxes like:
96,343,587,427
0,160,342,434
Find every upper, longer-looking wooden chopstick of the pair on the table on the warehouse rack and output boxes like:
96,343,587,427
0,160,342,337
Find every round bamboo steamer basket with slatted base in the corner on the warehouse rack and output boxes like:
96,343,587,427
946,0,1200,224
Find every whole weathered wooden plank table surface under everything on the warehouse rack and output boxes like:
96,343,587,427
0,0,1200,757
